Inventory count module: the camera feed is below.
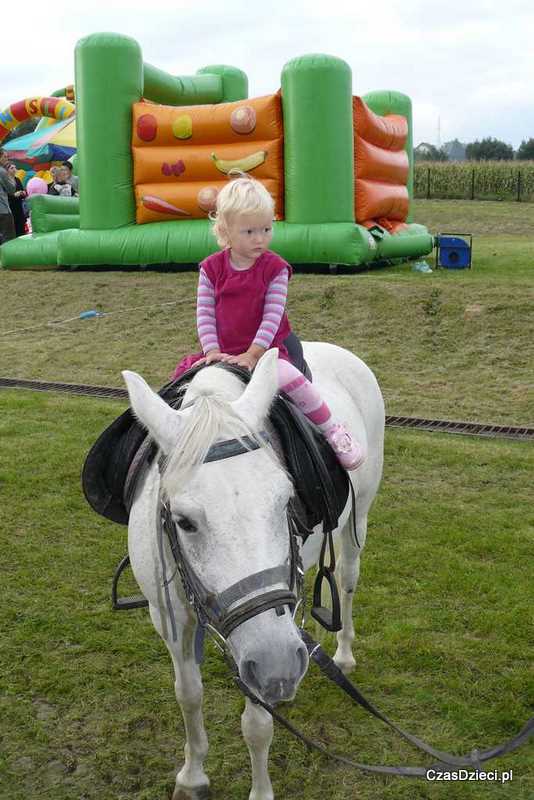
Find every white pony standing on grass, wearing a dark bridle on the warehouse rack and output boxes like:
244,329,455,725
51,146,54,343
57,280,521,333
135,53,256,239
123,343,384,800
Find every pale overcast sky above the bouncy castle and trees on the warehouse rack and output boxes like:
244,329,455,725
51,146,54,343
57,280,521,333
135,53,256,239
0,0,534,147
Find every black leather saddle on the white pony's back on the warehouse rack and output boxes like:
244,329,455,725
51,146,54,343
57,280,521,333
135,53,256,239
82,362,349,538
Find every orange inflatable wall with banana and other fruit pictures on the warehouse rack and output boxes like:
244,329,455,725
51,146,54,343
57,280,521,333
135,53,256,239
132,93,284,223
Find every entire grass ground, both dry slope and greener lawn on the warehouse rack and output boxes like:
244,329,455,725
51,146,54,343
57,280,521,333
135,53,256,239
0,201,534,800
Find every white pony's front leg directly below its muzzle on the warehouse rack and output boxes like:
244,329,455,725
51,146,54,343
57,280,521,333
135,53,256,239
241,697,274,800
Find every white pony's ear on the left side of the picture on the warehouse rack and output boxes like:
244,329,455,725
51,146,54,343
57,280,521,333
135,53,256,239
122,370,181,454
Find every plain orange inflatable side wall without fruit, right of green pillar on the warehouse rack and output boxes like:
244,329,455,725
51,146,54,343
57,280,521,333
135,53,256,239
352,97,409,233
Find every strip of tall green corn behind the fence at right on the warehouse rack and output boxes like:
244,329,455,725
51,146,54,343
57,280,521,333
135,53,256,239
414,161,534,203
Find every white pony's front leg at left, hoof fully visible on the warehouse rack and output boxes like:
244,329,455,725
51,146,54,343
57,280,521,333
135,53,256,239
150,606,213,800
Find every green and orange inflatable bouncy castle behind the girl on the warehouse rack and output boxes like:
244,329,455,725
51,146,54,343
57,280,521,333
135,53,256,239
0,34,432,269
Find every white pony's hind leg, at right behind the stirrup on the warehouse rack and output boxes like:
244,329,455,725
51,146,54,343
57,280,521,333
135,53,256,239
334,511,367,674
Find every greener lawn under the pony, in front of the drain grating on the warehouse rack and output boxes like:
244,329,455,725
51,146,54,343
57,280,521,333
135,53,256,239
0,390,534,800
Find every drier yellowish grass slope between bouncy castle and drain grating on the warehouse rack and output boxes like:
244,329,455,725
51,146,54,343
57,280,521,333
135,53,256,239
0,201,534,425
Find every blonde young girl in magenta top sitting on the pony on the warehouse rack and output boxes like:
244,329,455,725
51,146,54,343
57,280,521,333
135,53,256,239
173,176,365,470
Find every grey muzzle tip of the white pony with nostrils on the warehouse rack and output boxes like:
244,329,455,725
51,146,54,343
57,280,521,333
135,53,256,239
240,643,308,705
